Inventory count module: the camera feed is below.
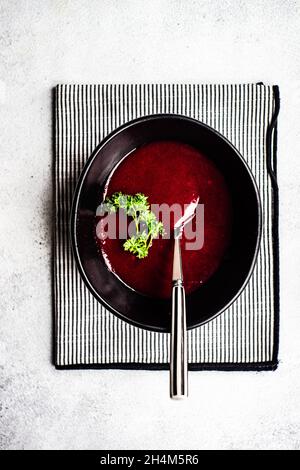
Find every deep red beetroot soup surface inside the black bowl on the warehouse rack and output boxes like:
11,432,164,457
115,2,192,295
96,141,231,298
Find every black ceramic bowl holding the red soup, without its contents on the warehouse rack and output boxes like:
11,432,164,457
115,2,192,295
71,114,261,331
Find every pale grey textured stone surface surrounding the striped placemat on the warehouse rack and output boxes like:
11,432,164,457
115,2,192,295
0,0,300,449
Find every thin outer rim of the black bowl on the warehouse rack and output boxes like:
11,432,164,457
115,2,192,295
69,113,262,333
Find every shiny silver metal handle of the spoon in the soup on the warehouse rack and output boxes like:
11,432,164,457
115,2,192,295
170,280,188,399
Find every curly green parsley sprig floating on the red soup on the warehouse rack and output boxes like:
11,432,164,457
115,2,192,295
104,192,164,259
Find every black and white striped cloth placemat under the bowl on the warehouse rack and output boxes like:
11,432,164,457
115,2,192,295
54,84,278,370
